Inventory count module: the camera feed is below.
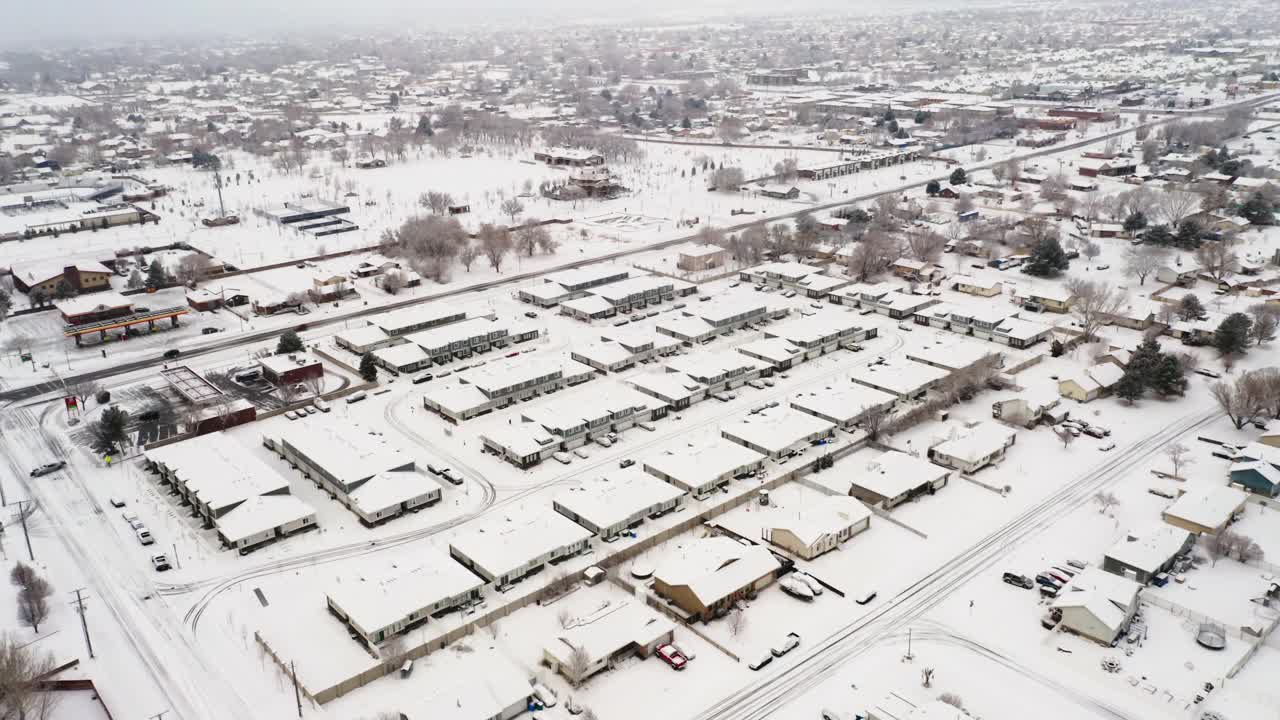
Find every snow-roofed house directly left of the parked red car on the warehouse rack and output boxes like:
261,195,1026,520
543,603,676,687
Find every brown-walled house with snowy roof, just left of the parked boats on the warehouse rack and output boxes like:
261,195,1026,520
653,536,782,623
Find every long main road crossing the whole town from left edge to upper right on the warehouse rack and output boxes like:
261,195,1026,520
0,94,1280,402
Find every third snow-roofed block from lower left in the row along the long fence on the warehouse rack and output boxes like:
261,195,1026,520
552,466,685,542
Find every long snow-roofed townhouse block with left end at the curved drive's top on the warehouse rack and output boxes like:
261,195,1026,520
422,353,595,423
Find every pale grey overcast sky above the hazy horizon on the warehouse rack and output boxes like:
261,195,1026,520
0,0,977,50
